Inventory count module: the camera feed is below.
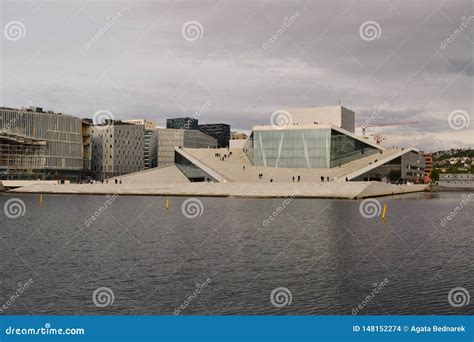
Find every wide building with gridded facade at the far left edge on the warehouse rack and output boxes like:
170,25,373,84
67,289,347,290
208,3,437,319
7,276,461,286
0,107,90,181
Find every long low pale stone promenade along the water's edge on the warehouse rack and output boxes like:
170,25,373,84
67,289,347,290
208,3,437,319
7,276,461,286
5,181,426,199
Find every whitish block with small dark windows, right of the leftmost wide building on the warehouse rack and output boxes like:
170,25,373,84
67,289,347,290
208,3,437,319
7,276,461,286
92,121,145,179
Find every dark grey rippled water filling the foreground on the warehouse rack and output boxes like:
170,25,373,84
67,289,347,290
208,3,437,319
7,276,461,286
0,193,474,315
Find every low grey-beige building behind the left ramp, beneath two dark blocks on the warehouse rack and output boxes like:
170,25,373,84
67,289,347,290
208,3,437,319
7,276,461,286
150,128,217,167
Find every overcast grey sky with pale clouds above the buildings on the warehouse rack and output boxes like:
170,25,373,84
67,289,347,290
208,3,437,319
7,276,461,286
0,0,474,151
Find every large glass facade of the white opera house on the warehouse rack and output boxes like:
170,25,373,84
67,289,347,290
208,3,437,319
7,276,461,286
244,128,378,168
